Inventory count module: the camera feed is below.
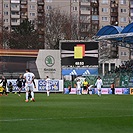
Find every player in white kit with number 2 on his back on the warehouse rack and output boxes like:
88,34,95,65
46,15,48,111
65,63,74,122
23,69,35,102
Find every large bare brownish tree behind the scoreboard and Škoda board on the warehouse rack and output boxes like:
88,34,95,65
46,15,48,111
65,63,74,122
45,9,78,49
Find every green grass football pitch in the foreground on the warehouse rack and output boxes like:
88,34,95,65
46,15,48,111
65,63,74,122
0,94,133,133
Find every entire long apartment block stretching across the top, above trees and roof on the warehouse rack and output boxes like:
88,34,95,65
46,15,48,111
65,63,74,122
0,0,133,50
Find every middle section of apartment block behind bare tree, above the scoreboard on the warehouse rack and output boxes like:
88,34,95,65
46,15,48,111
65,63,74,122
45,0,99,39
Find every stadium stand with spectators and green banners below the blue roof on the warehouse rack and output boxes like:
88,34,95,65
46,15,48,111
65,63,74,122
103,61,133,87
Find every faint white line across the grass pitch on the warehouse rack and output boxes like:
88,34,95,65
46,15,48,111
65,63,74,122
0,115,133,122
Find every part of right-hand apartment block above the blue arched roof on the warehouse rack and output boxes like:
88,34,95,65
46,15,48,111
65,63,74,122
99,0,130,28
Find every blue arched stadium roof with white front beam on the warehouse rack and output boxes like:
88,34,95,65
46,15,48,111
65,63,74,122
95,22,133,44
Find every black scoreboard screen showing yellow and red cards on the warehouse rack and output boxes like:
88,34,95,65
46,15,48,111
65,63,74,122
60,41,98,66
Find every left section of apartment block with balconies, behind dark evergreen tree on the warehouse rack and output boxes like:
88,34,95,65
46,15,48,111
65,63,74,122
0,0,44,46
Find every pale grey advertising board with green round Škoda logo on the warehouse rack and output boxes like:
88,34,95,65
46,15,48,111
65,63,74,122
36,50,61,79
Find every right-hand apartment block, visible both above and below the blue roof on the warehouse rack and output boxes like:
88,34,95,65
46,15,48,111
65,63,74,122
99,0,131,66
